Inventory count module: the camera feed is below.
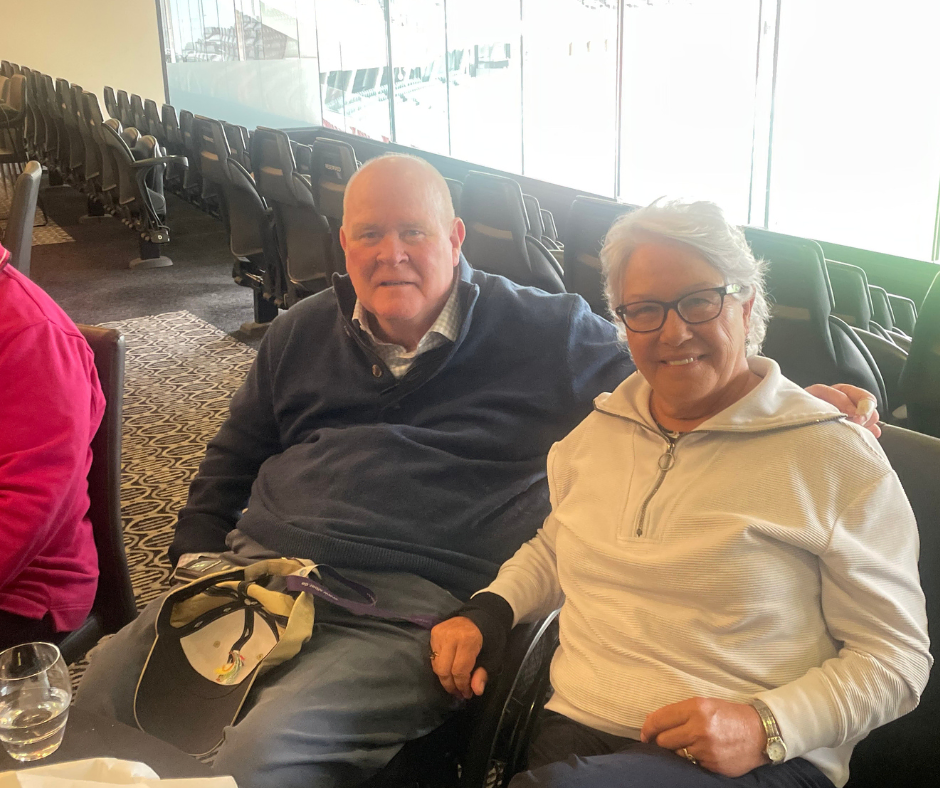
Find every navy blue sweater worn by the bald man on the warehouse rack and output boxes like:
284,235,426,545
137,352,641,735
170,262,633,598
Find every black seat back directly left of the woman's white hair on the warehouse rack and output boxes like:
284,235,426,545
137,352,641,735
564,195,636,320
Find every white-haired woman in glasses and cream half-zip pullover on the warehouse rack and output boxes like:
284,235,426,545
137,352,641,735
431,202,931,788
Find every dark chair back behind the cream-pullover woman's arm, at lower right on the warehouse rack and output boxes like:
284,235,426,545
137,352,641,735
846,425,940,788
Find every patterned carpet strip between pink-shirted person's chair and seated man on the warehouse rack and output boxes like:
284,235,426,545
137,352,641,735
72,312,255,684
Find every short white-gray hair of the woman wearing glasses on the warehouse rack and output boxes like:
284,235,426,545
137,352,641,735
601,198,770,356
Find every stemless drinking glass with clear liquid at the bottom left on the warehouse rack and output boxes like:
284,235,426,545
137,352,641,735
0,643,72,761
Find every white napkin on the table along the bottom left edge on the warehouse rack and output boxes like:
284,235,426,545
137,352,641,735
0,758,238,788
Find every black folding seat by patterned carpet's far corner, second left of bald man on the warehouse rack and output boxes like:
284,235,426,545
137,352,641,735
193,115,284,330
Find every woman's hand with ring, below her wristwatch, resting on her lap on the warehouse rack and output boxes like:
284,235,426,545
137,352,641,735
640,698,769,777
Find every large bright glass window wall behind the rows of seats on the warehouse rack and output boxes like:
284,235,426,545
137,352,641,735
158,0,940,258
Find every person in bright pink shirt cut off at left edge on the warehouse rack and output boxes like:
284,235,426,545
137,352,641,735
0,246,105,650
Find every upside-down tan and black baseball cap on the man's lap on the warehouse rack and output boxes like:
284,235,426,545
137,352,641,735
134,558,316,755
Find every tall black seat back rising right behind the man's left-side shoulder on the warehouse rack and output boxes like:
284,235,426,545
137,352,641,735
251,126,337,306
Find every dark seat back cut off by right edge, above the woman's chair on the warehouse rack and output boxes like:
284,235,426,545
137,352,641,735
901,274,940,438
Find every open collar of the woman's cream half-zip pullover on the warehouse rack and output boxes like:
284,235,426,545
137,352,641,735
594,356,844,432
